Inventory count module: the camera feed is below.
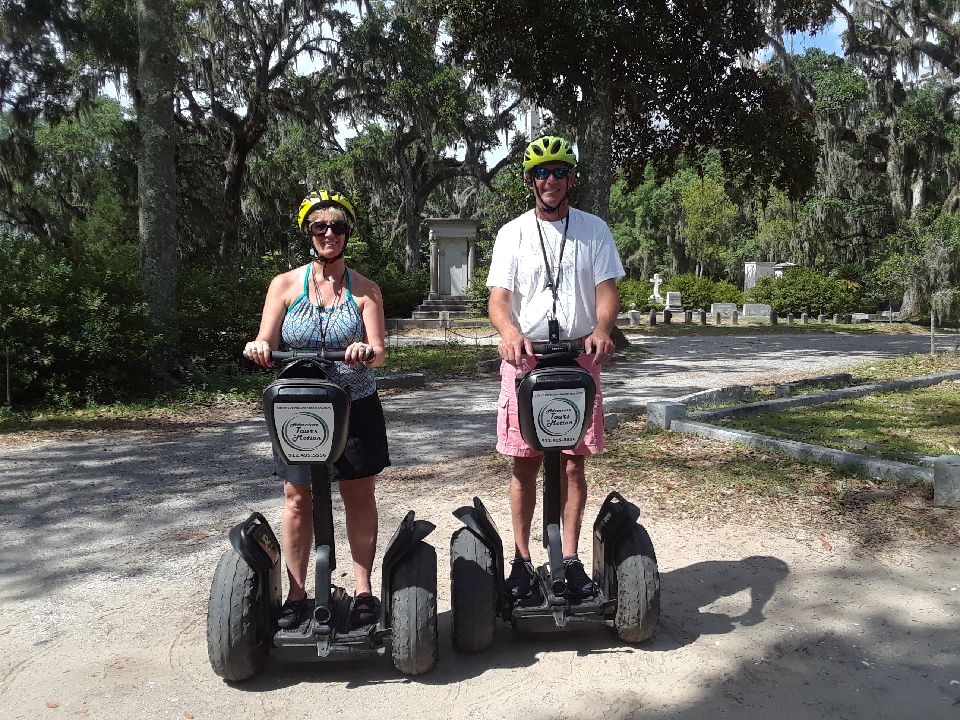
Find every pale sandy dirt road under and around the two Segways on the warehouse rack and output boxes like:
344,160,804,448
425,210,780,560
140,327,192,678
0,338,960,720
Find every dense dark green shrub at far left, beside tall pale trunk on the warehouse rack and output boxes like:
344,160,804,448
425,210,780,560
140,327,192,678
0,229,159,407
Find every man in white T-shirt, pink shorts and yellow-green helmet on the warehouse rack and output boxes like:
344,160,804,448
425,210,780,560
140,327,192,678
487,136,625,601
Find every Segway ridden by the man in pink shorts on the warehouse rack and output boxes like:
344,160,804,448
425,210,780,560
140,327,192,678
450,341,660,652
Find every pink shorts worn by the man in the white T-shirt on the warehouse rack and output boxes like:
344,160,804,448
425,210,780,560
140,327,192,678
497,355,603,457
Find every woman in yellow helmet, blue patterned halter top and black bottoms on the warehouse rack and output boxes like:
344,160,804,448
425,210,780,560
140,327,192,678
243,190,390,629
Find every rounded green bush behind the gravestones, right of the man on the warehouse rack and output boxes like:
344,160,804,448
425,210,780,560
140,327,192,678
748,268,859,316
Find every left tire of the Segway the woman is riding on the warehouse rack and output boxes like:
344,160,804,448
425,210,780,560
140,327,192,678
207,549,272,682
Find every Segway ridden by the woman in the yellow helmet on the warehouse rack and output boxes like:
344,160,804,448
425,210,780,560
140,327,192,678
207,350,437,681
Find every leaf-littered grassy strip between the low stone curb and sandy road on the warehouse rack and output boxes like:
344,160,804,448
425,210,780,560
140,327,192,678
587,416,960,547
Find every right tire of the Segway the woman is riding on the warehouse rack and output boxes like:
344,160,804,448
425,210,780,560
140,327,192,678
390,542,437,675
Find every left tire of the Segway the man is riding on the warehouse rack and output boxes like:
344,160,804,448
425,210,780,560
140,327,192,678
450,528,497,653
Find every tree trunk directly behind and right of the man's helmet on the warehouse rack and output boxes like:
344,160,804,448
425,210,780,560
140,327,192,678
577,82,613,220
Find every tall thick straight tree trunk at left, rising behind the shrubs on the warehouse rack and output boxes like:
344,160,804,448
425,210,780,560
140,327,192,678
135,0,180,380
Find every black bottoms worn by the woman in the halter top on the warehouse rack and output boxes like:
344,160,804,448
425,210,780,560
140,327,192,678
273,393,390,485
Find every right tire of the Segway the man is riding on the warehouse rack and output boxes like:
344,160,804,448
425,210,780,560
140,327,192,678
614,525,660,643
